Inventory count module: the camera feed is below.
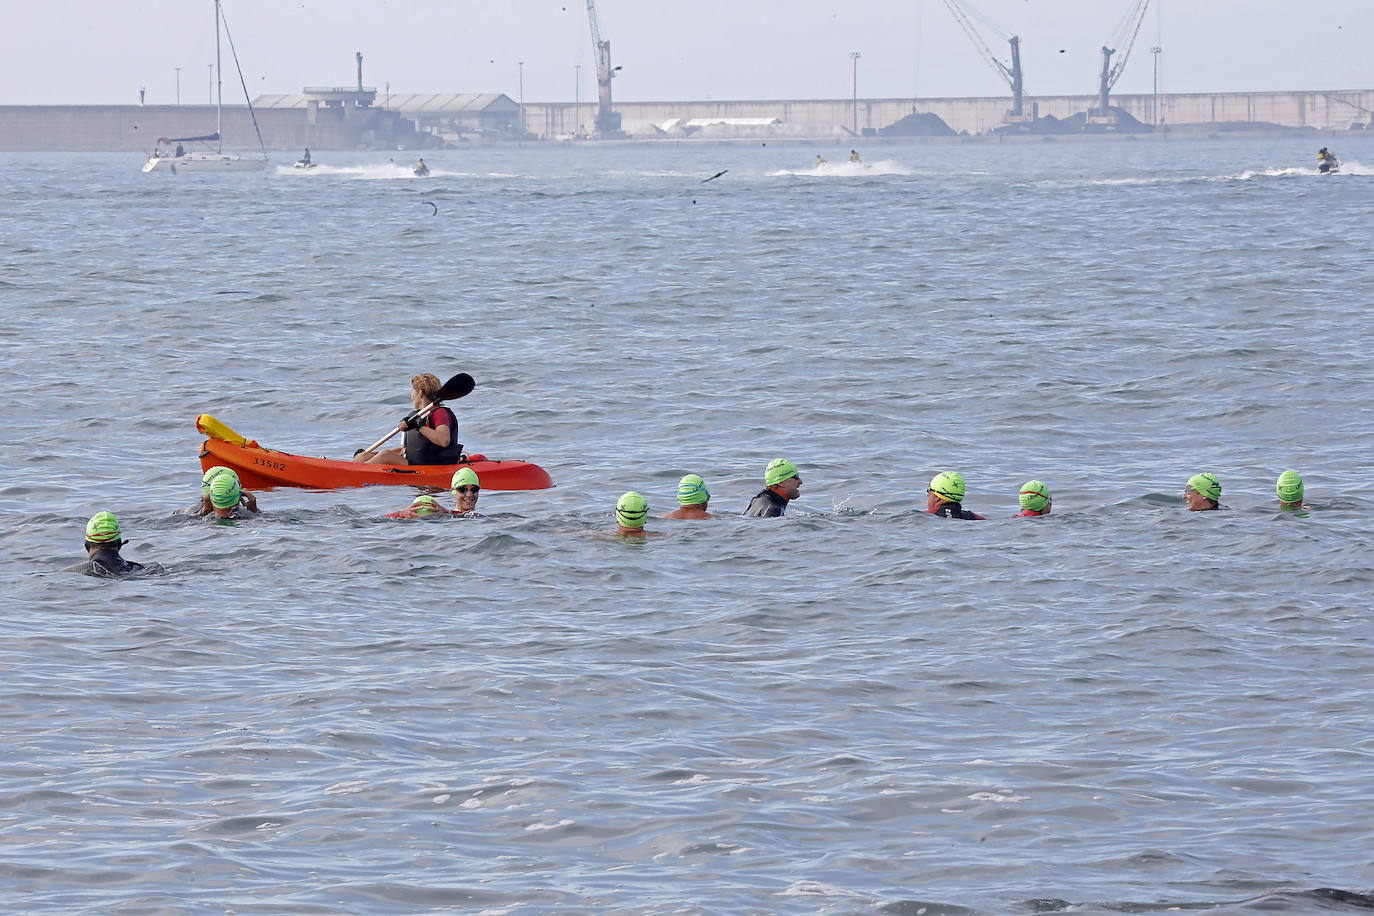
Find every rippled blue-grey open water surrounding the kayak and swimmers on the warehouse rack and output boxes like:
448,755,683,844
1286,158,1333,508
0,137,1374,916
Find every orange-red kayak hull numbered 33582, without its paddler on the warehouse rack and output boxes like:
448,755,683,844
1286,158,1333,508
201,438,554,490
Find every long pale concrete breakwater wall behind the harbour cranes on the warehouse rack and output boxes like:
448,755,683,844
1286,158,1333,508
0,89,1374,151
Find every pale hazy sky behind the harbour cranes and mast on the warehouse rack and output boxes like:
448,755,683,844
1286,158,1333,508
0,0,1374,104
